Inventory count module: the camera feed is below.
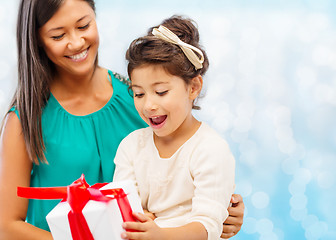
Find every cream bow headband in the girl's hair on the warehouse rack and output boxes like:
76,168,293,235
152,25,204,70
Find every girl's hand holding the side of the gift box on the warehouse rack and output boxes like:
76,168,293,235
121,213,164,240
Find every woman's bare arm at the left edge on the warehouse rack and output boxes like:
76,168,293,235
0,112,52,240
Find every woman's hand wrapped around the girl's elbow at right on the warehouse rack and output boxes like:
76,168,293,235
221,194,245,239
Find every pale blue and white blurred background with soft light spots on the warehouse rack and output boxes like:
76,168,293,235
0,0,336,240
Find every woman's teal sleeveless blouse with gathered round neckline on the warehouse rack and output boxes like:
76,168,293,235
12,71,147,230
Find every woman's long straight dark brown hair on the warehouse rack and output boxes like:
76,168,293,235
5,0,97,164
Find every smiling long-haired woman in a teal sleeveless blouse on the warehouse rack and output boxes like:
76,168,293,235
0,0,244,239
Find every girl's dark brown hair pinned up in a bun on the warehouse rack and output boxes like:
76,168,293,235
126,15,209,109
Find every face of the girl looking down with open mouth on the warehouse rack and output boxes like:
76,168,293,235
131,65,199,137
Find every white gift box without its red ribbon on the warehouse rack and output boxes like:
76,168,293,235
46,181,143,240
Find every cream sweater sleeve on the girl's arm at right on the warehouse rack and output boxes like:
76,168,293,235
189,136,235,240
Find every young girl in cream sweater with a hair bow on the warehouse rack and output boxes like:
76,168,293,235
114,16,235,240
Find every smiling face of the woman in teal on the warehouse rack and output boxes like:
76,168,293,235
39,0,99,76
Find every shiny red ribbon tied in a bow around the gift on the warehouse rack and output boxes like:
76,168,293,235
17,174,136,240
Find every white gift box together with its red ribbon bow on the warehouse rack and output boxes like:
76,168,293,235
18,176,143,240
